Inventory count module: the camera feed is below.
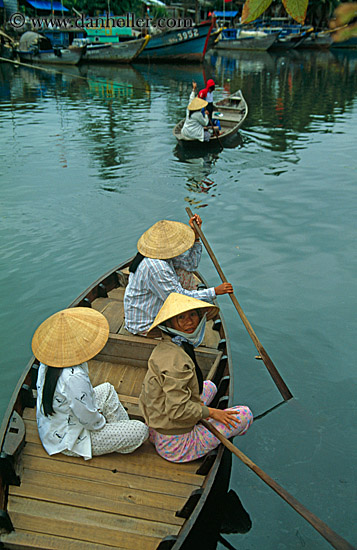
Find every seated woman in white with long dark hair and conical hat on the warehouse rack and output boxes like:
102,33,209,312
32,307,148,460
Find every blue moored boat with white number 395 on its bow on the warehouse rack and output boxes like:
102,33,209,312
137,21,220,62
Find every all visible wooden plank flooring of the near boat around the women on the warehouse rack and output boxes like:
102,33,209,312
0,287,221,550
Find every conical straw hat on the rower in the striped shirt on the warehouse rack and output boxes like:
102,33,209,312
137,220,195,260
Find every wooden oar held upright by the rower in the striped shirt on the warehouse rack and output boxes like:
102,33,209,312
186,207,293,401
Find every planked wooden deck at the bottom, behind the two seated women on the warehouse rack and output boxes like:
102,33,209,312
2,408,204,550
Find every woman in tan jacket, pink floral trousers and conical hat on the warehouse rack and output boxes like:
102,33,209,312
139,293,253,462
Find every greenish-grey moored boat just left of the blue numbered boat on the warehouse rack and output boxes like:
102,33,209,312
78,35,150,63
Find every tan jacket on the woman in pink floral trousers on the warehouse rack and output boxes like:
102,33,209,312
139,335,209,435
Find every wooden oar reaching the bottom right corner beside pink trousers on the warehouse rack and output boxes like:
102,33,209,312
201,420,354,550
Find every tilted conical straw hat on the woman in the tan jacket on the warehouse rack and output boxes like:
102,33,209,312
148,292,219,333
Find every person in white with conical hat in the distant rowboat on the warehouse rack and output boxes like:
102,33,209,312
181,82,218,142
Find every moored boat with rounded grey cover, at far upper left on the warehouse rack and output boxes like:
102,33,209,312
16,31,86,65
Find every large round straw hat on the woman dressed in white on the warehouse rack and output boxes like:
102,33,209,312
32,307,109,368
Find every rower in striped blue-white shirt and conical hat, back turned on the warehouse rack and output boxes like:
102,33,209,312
121,214,233,336
